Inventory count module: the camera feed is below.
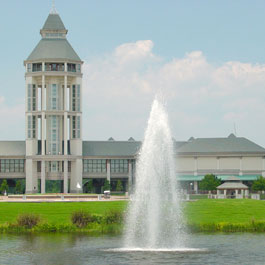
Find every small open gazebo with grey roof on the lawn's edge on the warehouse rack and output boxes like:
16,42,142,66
217,176,248,199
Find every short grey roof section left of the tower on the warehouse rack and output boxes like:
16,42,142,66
0,141,26,156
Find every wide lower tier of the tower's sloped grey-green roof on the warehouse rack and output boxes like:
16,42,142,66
27,38,81,62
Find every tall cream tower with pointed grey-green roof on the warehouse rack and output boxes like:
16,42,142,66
24,8,83,193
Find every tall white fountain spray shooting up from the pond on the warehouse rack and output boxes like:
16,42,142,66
124,97,185,250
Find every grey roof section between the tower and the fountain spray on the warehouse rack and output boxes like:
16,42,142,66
83,141,141,156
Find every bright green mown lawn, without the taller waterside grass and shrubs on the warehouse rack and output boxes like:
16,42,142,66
0,199,265,224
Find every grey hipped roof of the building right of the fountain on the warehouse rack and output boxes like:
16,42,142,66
178,134,265,154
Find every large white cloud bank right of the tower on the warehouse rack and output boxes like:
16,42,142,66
83,40,265,145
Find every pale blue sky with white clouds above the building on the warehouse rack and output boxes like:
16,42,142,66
0,0,265,146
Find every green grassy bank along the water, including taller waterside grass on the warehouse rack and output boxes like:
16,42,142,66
0,199,265,234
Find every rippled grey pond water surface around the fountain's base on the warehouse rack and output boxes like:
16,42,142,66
0,234,265,265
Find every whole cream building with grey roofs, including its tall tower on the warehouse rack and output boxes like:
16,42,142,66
0,9,265,193
